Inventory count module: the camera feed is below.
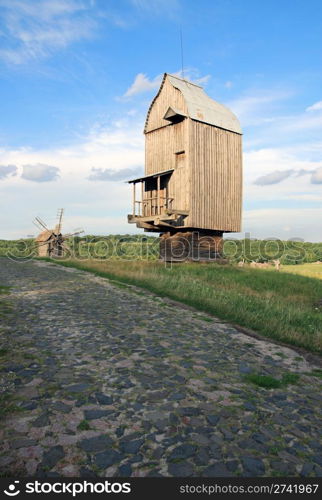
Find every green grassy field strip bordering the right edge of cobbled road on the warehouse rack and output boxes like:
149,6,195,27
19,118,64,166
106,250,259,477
44,260,322,354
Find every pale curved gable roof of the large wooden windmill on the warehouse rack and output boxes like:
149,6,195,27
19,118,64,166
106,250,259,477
148,73,242,134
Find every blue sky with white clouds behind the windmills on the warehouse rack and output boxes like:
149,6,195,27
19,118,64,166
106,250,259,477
0,0,322,241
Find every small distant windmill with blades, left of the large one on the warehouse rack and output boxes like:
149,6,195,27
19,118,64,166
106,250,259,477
34,208,84,257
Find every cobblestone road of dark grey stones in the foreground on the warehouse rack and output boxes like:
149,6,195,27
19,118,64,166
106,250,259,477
0,259,322,477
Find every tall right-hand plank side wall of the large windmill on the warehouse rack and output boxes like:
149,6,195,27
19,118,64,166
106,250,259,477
189,120,242,231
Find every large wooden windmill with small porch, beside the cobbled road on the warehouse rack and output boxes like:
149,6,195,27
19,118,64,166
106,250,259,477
128,73,242,260
